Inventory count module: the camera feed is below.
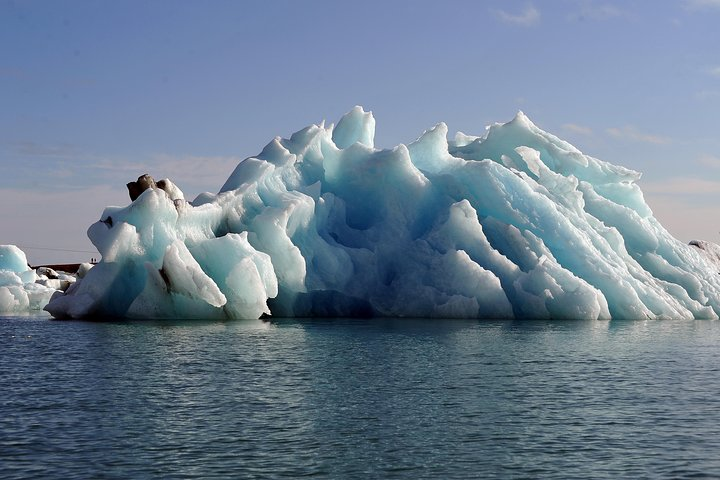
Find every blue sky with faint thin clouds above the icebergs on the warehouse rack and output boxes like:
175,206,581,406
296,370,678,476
0,0,720,263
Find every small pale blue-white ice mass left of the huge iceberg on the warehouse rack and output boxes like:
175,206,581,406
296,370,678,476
0,245,75,314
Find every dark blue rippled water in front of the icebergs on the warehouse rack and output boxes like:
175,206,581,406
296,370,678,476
0,317,720,479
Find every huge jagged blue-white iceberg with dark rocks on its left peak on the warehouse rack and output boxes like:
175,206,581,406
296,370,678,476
46,107,720,319
